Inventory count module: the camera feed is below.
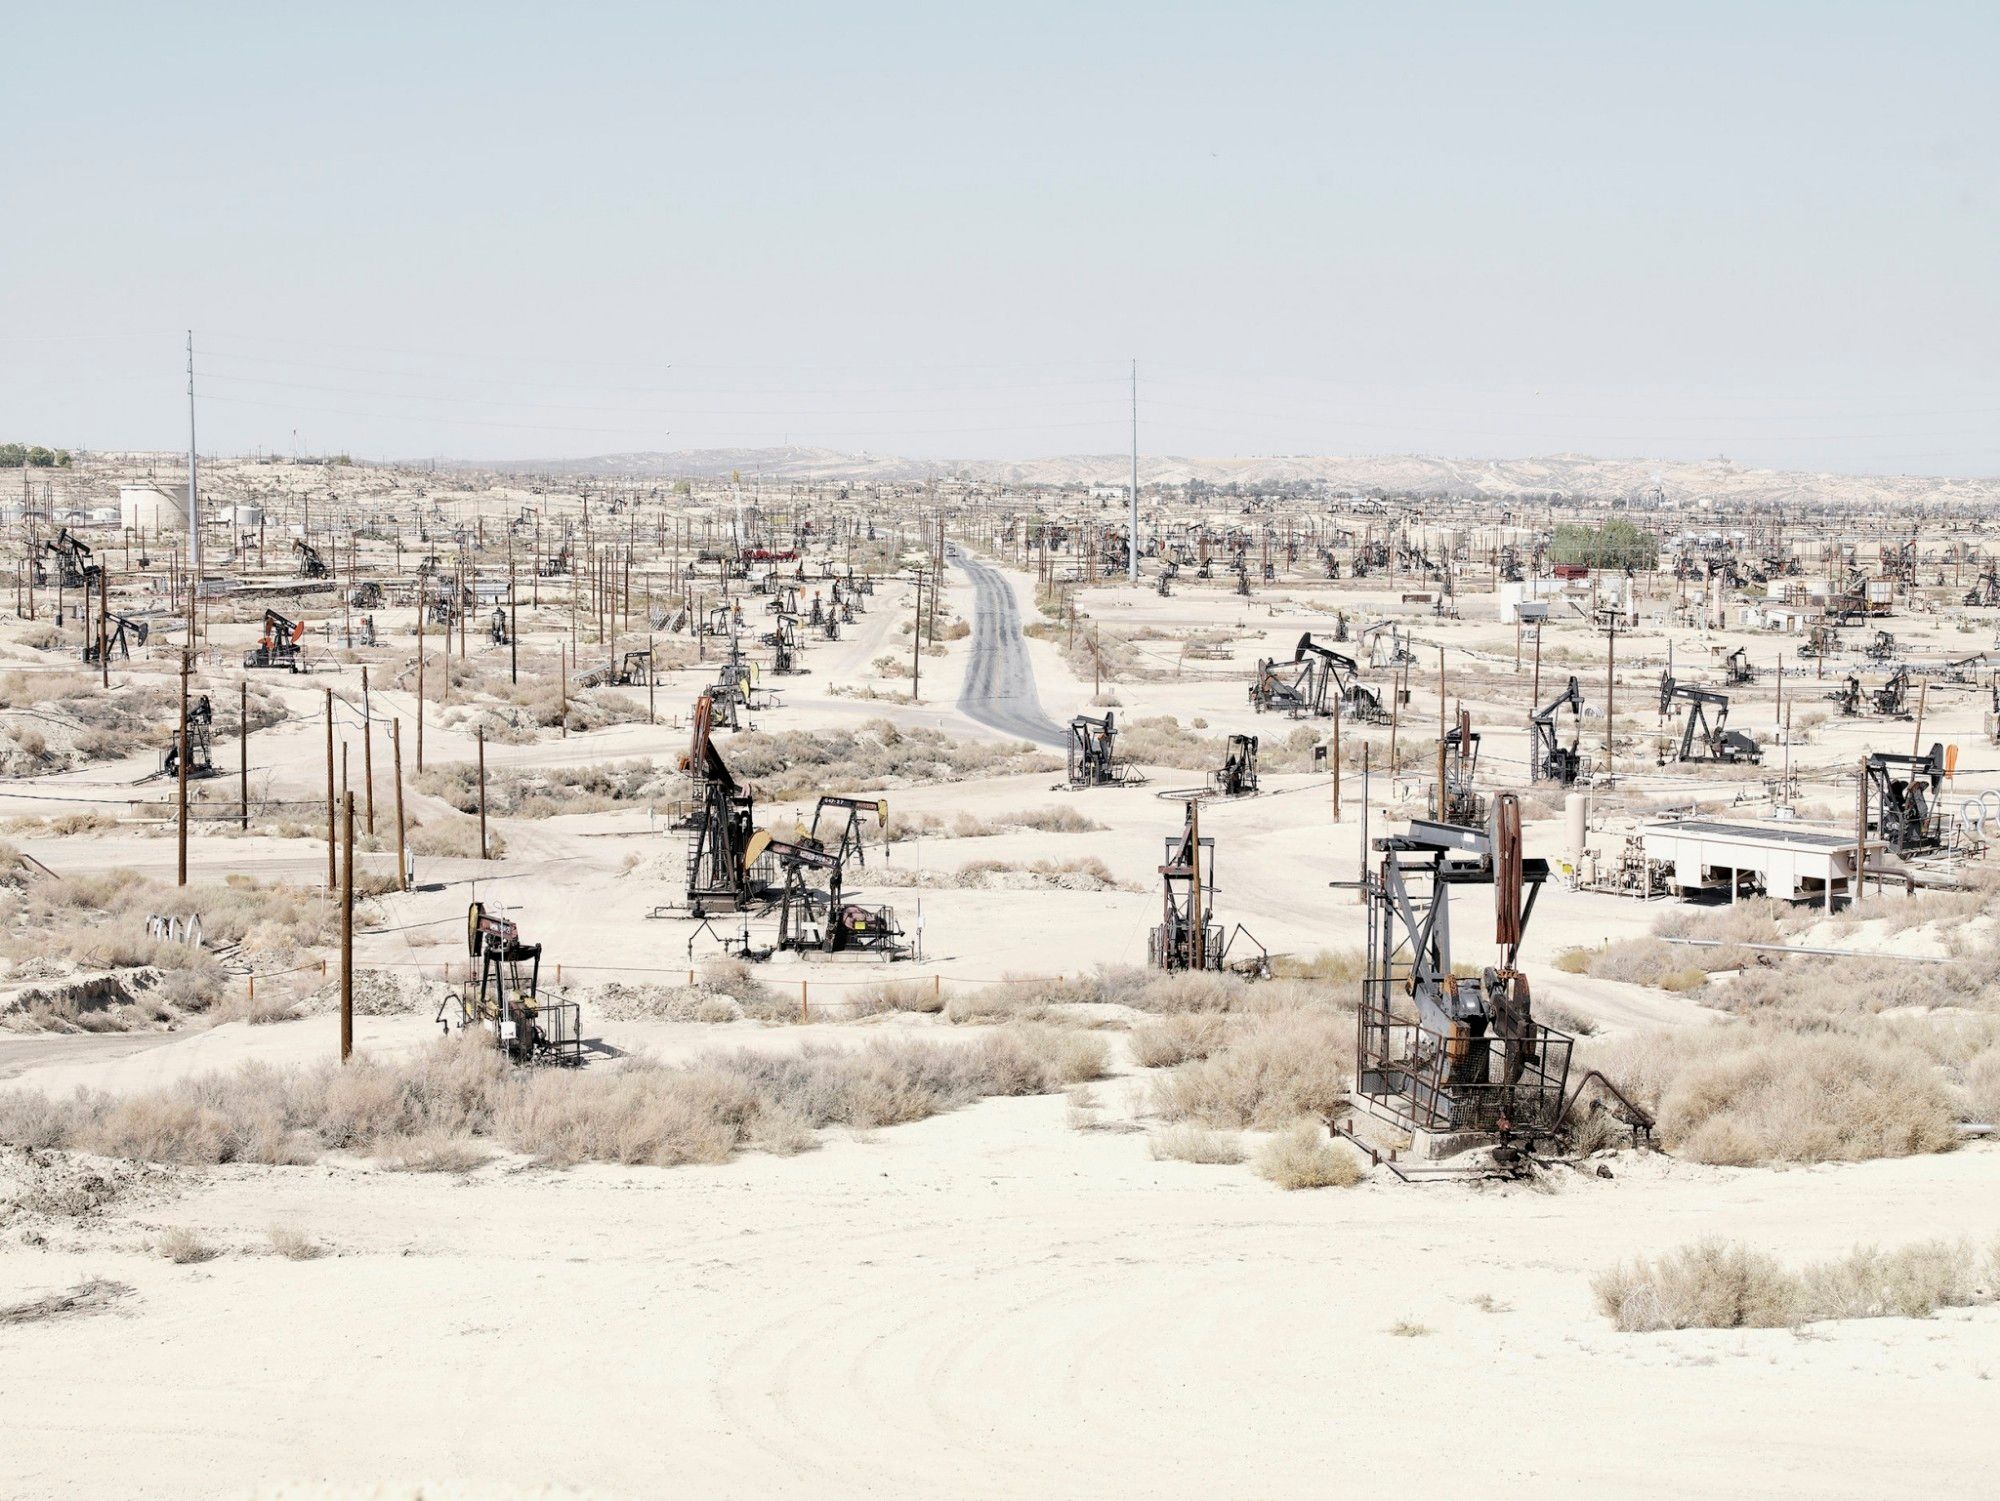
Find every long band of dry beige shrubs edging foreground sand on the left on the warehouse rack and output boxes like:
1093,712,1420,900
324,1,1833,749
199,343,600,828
0,1025,1108,1171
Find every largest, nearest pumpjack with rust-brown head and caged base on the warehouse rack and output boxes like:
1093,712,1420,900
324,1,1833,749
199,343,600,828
1354,793,1572,1151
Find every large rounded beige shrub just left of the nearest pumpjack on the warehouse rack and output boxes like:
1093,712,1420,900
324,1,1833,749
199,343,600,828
1152,1009,1354,1129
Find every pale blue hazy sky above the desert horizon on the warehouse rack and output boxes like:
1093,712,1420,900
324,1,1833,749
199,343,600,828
0,0,2000,474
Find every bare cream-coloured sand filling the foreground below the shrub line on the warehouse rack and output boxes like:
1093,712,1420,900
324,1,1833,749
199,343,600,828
0,1019,2000,1499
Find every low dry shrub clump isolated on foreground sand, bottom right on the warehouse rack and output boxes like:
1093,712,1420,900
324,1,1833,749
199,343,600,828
1592,1241,2000,1333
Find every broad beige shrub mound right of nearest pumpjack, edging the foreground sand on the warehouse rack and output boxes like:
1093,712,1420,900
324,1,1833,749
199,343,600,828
1608,1025,1958,1165
